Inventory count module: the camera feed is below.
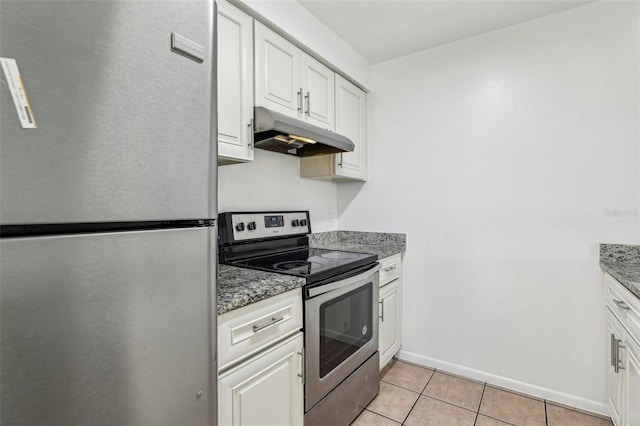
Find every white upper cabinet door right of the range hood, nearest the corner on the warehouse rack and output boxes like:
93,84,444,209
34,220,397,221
335,75,367,180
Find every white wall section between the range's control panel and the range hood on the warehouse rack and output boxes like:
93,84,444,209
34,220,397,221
218,149,338,232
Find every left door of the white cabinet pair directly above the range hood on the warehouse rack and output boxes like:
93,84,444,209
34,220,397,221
255,21,303,118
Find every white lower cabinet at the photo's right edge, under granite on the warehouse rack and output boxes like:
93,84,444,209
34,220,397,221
605,274,640,426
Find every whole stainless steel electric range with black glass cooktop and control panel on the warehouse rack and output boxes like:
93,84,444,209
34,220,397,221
218,211,380,426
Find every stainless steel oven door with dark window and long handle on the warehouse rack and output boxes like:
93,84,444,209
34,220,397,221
305,263,380,411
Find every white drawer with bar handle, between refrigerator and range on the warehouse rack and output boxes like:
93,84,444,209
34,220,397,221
218,288,302,371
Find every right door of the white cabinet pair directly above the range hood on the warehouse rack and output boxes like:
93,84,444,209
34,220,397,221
302,54,335,130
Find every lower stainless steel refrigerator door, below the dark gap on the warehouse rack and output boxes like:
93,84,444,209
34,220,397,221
0,228,217,426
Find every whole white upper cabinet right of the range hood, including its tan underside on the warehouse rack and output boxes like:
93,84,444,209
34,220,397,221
300,74,367,180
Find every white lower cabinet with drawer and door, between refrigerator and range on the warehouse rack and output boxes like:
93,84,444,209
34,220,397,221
218,288,304,426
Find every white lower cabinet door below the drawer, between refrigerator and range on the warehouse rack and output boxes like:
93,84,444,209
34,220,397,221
218,333,304,426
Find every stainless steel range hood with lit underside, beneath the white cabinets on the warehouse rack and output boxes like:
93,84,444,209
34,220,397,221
253,107,355,157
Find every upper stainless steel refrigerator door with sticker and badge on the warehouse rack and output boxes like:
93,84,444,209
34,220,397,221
0,0,217,224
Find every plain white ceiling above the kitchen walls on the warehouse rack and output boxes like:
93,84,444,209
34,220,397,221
298,0,593,64
